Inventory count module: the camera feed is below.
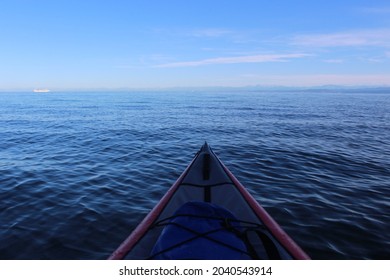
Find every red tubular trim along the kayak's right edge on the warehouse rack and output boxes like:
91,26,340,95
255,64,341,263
217,160,310,260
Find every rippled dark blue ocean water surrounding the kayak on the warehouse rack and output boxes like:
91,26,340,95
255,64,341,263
0,90,390,259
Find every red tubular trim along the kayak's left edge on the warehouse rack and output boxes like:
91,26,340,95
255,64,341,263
108,154,199,260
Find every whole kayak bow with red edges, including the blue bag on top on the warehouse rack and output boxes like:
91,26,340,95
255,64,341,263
109,143,309,259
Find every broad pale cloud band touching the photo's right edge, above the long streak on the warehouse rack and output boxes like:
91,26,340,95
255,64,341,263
292,29,390,47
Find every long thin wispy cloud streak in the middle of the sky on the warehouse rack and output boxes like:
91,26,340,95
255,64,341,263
155,53,310,68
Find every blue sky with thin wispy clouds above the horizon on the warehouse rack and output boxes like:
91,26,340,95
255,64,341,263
0,0,390,90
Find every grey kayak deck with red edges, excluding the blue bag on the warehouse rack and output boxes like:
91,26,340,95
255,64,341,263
109,143,309,259
